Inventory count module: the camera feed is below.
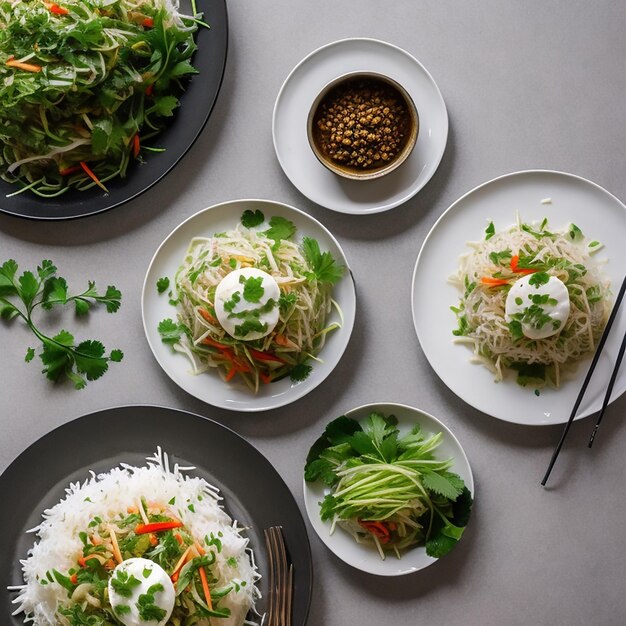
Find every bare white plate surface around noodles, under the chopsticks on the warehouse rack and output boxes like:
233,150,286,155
411,170,626,425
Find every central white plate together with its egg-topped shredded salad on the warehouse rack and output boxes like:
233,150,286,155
142,200,356,411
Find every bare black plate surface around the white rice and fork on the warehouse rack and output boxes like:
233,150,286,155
0,406,313,626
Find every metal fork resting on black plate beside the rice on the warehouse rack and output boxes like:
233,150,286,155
265,526,293,626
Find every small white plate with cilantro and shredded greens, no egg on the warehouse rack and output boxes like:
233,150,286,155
304,402,474,576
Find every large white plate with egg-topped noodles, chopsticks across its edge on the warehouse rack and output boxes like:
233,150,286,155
412,170,626,425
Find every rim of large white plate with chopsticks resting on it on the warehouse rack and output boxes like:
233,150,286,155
411,168,626,427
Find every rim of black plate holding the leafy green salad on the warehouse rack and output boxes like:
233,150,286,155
0,0,230,222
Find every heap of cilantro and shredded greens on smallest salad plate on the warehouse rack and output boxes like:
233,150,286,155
304,412,472,558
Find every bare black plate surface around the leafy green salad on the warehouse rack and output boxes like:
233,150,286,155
0,0,228,220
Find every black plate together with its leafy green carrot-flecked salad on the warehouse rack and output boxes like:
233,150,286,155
0,0,228,220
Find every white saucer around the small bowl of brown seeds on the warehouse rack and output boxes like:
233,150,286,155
272,38,448,214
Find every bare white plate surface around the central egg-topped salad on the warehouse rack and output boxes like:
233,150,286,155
141,200,356,411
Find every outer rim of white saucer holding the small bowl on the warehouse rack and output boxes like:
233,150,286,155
272,37,450,215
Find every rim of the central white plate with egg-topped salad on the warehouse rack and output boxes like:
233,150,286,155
141,198,357,413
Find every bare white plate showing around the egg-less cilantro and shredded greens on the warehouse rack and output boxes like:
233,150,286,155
304,402,474,576
